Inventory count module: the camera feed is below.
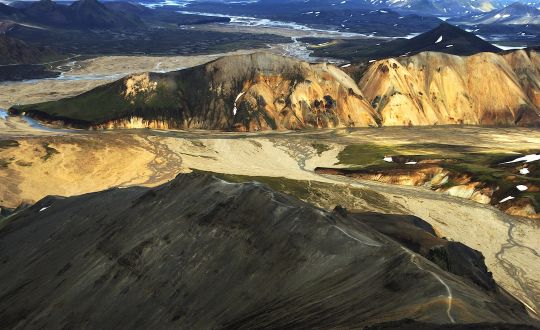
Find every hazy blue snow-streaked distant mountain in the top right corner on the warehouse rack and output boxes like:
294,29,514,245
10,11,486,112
451,2,540,25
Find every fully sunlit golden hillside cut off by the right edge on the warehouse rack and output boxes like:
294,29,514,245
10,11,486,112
359,50,540,126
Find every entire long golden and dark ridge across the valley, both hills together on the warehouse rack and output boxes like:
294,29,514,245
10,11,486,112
10,50,540,131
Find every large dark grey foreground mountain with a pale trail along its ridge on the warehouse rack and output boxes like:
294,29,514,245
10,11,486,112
0,174,535,329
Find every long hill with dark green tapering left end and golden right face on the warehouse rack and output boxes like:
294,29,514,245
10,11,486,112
11,53,379,131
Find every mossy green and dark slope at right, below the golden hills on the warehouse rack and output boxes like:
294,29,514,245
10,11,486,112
338,143,540,210
